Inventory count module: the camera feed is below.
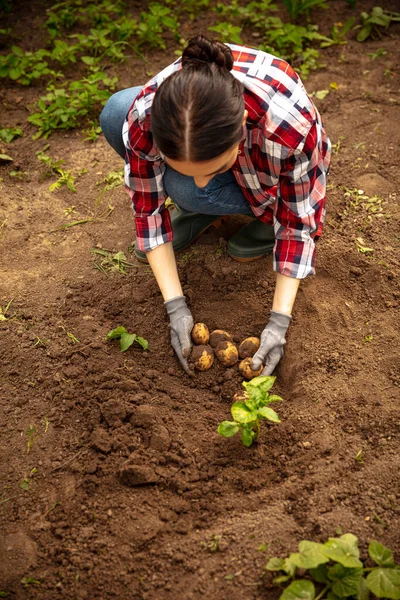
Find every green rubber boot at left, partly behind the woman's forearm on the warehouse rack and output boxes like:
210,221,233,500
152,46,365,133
135,206,227,262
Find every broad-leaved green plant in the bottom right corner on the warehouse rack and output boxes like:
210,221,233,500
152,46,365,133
266,533,400,600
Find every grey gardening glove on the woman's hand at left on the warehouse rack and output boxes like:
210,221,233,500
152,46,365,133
164,296,194,374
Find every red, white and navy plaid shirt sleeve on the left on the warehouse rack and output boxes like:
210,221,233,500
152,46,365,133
123,110,173,252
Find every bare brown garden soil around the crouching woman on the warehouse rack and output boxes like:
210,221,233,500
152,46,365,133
0,2,400,600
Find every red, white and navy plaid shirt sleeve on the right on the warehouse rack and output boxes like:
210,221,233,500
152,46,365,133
274,123,326,279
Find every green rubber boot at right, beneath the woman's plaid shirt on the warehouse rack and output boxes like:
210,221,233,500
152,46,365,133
226,219,275,262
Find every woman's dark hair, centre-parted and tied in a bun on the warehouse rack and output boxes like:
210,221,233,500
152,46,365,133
151,35,244,162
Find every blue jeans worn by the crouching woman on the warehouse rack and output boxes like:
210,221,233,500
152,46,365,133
100,86,254,216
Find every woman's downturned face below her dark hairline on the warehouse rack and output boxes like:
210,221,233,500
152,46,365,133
165,110,248,188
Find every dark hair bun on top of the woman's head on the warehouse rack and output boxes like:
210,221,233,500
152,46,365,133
182,35,233,71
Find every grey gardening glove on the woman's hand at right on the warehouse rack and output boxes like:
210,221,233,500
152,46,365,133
251,310,292,375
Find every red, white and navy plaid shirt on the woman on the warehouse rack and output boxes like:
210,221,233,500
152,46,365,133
123,44,331,279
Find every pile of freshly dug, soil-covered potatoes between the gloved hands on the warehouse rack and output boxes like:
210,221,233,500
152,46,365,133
190,323,263,379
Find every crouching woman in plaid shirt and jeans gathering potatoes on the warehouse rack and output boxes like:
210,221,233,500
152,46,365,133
101,35,330,375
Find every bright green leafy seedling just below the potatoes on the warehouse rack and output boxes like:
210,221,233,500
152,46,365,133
218,375,282,447
